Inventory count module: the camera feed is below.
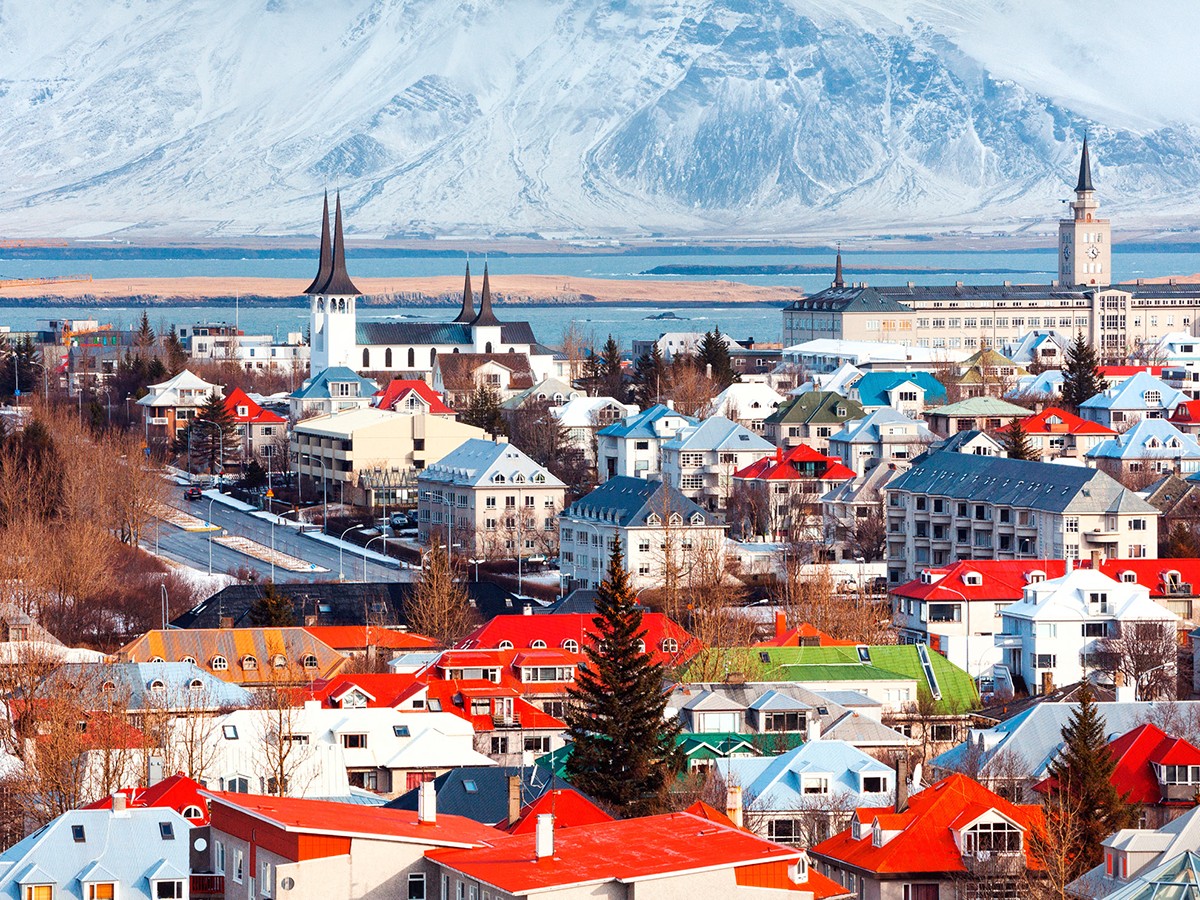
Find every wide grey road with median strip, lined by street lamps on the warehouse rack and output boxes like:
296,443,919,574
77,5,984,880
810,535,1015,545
145,485,413,583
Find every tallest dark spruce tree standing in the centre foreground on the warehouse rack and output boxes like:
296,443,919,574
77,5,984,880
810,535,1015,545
566,544,683,816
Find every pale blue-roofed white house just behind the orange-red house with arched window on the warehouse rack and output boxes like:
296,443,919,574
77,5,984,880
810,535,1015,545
714,739,896,846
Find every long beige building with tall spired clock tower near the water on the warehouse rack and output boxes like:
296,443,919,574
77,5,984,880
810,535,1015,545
784,137,1200,365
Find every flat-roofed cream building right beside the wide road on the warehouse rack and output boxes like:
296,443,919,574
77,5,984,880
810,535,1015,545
290,407,484,506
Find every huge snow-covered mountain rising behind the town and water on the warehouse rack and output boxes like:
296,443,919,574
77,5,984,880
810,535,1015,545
0,0,1200,236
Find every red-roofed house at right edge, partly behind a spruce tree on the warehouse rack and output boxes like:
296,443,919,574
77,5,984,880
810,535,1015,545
1033,722,1200,828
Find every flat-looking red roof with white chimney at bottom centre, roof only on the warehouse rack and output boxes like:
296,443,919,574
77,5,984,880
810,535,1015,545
426,812,800,895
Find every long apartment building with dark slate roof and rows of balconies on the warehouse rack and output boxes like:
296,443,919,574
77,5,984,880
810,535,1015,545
886,452,1159,584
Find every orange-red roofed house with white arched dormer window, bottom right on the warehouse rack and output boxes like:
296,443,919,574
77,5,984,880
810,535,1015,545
810,774,1044,898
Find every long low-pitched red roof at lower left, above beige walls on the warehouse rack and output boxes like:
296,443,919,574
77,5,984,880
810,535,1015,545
206,791,497,852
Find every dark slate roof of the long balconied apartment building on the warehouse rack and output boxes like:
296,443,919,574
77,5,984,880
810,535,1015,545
888,452,1157,515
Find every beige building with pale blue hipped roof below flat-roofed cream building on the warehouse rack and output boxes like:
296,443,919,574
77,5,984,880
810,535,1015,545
416,438,566,559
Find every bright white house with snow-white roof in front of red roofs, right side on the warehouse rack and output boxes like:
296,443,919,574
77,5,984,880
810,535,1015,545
996,569,1180,694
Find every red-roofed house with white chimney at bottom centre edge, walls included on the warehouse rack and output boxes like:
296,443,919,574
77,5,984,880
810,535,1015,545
426,812,848,900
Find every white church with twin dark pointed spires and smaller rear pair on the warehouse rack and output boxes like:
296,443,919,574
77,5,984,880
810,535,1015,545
304,194,552,382
